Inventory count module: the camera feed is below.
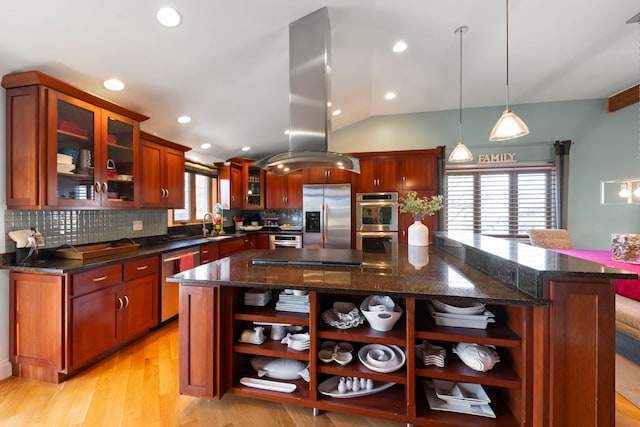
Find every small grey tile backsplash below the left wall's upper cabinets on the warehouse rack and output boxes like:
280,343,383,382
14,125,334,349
4,209,168,253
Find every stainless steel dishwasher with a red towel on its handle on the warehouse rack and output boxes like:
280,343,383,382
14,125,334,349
160,246,200,323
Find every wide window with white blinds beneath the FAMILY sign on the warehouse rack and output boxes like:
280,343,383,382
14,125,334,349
445,165,557,237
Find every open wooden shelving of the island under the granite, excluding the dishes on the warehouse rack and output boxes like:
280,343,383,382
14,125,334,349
179,284,533,426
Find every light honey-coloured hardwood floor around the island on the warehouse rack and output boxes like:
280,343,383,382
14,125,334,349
0,322,640,427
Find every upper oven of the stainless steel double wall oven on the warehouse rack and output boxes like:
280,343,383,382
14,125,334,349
356,192,398,232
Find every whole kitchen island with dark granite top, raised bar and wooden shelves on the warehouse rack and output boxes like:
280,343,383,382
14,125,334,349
171,233,635,426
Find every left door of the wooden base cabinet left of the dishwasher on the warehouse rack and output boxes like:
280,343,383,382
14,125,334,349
71,286,119,368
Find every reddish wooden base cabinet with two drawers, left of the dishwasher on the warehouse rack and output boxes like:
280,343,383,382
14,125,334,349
9,255,159,383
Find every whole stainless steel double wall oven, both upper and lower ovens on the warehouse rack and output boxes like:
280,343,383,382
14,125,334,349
356,192,398,268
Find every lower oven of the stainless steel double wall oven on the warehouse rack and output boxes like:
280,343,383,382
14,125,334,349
356,231,398,268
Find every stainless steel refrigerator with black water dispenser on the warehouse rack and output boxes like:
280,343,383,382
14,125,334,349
302,184,351,249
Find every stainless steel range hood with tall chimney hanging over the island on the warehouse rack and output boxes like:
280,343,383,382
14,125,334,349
255,7,360,175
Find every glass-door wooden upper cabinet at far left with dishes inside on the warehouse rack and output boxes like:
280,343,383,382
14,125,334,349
2,71,148,209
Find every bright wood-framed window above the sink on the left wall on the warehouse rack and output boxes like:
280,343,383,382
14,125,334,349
171,162,218,225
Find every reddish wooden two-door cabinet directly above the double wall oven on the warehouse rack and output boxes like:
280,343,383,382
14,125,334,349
353,156,399,193
